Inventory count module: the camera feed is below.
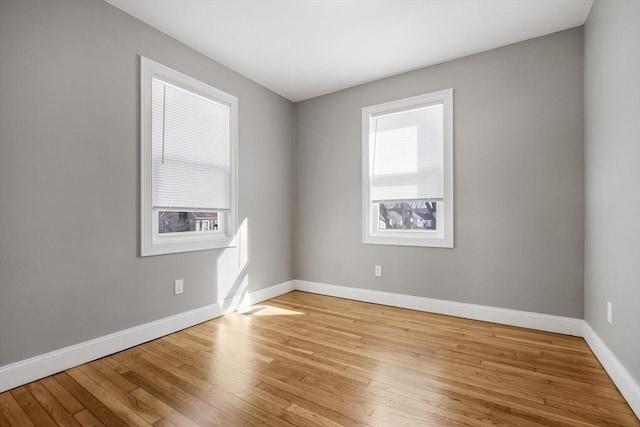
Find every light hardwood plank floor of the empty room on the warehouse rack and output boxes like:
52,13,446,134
0,292,640,427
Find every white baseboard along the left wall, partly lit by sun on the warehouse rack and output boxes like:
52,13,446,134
0,280,295,392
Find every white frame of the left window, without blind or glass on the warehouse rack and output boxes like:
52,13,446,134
140,56,238,256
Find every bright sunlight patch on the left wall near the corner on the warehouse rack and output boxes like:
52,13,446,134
217,218,249,312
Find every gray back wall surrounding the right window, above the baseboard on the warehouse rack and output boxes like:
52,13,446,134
295,28,584,318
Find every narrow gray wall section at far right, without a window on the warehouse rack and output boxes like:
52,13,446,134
584,0,640,383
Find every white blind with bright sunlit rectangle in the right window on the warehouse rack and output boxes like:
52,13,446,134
370,102,444,203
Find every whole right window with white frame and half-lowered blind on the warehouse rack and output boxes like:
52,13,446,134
362,89,453,248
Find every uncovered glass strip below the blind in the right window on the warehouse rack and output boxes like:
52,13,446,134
377,202,437,230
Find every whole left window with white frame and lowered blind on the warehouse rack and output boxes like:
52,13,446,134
140,57,238,256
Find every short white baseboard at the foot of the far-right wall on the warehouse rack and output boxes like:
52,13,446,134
582,321,640,419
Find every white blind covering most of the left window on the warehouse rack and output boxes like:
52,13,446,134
152,78,230,211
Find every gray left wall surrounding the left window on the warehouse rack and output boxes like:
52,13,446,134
0,0,294,366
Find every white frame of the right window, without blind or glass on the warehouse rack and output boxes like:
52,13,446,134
362,89,454,248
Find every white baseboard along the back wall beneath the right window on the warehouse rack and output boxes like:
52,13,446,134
295,280,583,337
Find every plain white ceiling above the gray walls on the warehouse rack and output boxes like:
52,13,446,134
106,0,593,101
